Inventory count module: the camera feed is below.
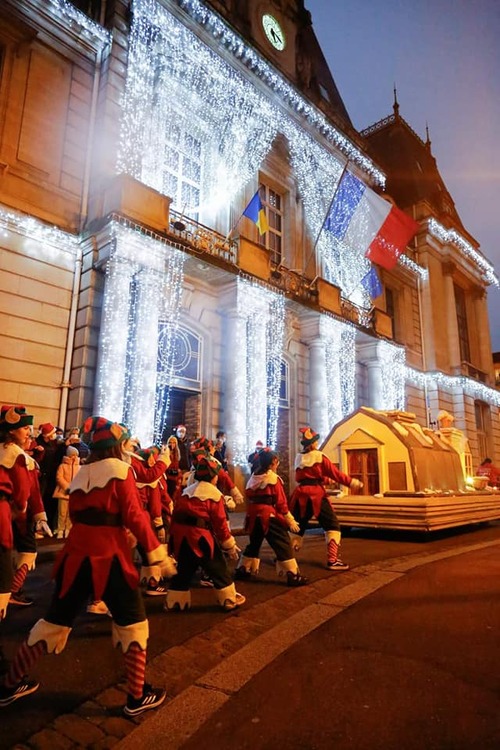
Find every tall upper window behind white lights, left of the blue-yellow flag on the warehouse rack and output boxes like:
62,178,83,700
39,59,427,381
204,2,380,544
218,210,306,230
162,123,202,221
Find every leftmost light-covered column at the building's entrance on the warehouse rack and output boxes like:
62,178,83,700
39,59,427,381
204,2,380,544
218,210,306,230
94,257,136,422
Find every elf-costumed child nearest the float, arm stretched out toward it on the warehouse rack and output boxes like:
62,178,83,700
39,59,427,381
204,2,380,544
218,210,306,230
290,427,363,570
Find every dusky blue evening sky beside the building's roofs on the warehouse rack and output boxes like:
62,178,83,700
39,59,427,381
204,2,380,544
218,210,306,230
305,0,500,351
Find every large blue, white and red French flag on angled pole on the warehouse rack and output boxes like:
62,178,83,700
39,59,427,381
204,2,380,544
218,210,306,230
324,170,418,271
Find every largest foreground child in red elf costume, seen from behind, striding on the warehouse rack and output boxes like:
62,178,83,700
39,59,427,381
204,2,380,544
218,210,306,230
0,417,175,716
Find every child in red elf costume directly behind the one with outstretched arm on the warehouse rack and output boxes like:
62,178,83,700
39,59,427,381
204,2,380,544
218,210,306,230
235,448,308,586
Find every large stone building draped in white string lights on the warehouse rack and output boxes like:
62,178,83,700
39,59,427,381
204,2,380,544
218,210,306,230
0,0,500,488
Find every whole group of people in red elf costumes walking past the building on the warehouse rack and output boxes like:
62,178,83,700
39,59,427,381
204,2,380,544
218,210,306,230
0,405,362,716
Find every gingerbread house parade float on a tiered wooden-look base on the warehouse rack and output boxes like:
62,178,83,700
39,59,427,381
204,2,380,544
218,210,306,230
321,406,500,531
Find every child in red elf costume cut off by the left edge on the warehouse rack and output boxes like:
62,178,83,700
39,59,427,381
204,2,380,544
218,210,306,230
0,406,52,607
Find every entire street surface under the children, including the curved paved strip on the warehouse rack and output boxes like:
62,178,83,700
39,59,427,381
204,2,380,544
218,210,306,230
0,514,500,750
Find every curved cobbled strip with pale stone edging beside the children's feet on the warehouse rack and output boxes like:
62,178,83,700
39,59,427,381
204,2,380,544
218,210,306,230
20,528,500,750
